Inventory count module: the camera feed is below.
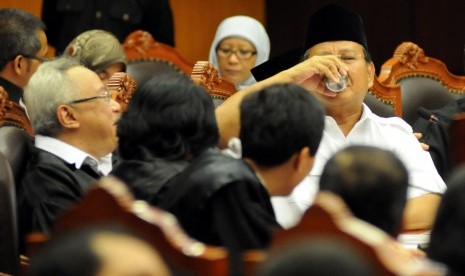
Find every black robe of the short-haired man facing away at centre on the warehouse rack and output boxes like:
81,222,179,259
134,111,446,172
159,149,281,252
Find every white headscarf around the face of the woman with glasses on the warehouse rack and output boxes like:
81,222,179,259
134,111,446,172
209,15,270,89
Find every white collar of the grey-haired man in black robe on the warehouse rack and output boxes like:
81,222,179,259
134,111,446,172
34,135,113,175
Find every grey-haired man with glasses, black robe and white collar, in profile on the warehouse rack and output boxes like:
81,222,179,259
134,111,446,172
17,58,121,246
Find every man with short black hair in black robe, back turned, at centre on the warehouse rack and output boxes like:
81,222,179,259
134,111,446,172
159,84,324,252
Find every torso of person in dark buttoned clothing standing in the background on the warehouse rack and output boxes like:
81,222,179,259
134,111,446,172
42,0,174,53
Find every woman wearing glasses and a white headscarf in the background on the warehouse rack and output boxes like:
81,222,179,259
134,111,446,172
209,15,270,90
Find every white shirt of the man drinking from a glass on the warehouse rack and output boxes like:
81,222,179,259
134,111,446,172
271,104,446,228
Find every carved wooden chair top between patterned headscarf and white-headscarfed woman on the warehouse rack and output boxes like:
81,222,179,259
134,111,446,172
123,30,194,86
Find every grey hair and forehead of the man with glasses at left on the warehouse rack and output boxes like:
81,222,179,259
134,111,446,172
24,58,81,137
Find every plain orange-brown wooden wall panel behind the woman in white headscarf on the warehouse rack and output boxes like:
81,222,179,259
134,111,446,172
171,0,265,62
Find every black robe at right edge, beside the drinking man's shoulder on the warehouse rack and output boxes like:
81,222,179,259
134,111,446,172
413,97,465,179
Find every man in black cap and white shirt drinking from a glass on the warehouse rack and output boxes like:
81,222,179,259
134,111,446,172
216,5,446,229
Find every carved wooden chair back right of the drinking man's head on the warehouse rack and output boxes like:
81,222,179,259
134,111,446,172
378,42,465,125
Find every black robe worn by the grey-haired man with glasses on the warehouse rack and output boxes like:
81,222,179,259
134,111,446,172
17,148,100,245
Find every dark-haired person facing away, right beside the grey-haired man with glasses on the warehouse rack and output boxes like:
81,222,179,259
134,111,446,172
112,69,219,205
